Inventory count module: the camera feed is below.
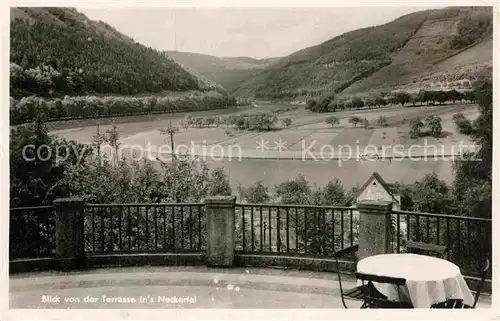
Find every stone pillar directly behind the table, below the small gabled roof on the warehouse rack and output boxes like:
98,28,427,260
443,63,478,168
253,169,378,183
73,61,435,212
357,201,392,259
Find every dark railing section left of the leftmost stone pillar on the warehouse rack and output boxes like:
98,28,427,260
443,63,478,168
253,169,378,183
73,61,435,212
9,206,56,259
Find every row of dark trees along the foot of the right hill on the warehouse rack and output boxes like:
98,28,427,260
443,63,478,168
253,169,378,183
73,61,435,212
306,89,476,113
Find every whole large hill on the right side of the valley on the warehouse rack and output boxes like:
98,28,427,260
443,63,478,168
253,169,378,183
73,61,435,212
235,7,493,100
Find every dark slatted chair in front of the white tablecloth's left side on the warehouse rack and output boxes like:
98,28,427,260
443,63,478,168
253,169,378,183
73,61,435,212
354,272,411,308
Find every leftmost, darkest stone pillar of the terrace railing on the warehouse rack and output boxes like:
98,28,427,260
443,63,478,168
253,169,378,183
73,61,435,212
54,197,85,270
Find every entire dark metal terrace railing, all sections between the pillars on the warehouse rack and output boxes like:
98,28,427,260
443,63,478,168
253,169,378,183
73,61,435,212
9,202,492,282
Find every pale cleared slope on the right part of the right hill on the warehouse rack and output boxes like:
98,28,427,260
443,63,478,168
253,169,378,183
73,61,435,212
344,8,493,94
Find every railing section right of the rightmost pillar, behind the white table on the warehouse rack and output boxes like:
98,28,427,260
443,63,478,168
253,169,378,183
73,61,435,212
391,211,492,276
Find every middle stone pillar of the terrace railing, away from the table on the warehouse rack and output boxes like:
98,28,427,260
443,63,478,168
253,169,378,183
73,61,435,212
205,196,236,267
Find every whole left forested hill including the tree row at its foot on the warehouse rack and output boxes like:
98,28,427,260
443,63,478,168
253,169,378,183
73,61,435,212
10,8,236,125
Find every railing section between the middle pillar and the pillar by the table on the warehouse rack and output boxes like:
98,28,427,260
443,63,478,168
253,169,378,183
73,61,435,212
234,204,359,258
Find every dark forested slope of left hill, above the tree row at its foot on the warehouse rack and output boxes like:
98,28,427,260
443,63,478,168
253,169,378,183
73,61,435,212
10,8,211,98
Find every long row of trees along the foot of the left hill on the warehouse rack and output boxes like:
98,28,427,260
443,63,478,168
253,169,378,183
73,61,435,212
10,91,236,125
